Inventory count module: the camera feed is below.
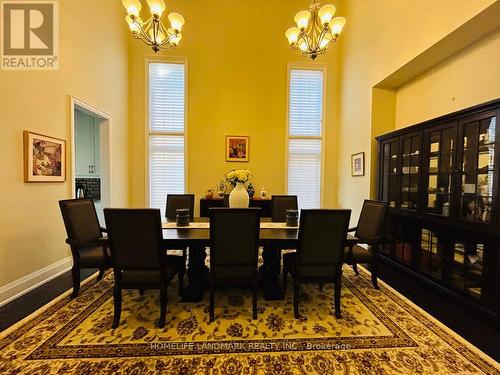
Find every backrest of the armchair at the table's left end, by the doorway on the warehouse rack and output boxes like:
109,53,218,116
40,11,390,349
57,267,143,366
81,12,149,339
59,198,102,242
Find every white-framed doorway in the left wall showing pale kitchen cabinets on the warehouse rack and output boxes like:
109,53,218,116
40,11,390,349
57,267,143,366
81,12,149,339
71,97,113,226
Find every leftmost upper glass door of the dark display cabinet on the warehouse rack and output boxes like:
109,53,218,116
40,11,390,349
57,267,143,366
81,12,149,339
381,138,399,207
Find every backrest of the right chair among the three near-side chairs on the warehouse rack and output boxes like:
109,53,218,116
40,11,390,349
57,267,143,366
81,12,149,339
297,209,351,275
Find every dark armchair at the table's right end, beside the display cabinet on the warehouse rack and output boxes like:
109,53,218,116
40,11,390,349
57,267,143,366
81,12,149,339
345,200,387,289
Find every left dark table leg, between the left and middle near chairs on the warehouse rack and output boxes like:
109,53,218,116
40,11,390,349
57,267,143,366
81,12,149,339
182,245,208,302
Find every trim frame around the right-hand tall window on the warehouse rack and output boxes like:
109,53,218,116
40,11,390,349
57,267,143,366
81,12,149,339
284,63,327,208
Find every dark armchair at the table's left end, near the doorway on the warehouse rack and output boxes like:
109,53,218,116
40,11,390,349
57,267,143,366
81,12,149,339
59,199,110,297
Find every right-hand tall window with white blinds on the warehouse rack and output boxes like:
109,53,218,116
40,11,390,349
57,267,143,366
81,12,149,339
287,68,324,208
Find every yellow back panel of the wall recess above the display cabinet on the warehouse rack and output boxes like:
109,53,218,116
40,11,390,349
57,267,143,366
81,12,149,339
396,31,500,128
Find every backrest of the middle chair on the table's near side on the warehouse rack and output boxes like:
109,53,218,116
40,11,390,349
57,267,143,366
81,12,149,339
210,208,260,276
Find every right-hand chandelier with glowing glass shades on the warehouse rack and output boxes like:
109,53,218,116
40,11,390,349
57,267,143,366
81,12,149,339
285,0,346,60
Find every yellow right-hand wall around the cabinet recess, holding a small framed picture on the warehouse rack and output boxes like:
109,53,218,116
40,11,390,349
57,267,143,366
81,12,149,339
338,0,494,220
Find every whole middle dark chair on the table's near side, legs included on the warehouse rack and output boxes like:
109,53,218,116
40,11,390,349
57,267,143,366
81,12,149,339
210,208,260,322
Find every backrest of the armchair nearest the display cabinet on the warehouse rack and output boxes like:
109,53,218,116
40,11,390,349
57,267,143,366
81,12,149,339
355,199,387,244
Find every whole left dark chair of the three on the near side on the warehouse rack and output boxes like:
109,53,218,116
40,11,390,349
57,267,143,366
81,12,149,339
104,208,184,328
